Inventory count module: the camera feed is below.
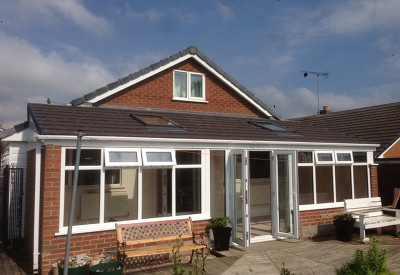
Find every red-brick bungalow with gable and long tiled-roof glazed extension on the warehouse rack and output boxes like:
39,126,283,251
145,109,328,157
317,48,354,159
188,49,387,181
0,46,378,274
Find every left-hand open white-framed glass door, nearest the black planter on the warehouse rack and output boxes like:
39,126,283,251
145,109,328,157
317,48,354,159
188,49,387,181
231,150,250,247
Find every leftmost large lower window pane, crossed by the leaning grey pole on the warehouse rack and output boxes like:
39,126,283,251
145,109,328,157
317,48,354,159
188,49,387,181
64,170,100,226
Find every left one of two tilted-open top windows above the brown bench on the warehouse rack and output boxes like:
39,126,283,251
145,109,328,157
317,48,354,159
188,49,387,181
104,148,142,167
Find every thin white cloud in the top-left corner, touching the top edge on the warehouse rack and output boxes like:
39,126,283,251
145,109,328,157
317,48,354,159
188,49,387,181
2,0,112,34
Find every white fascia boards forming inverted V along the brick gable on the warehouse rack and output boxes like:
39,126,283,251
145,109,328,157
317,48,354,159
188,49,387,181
88,54,272,117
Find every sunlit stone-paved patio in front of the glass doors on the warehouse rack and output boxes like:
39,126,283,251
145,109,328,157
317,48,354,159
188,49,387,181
128,234,400,275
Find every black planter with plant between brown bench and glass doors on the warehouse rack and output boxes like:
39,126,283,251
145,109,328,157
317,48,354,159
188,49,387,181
208,217,232,251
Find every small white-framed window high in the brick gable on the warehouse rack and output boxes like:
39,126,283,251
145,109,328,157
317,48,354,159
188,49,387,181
174,71,205,101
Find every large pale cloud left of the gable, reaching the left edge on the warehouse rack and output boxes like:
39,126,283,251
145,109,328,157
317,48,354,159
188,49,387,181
0,32,116,127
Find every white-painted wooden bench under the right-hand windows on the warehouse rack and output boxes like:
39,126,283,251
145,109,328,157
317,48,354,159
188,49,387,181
344,197,400,242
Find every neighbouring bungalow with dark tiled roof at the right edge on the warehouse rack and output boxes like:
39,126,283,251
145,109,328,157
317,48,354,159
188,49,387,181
294,102,400,205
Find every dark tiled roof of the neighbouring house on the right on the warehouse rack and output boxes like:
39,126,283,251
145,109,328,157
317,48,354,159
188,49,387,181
292,102,400,157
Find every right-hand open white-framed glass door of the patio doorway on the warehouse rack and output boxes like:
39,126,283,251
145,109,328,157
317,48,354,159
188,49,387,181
272,151,299,238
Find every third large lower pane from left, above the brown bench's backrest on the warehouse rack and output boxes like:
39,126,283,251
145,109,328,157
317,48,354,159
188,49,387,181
142,169,172,219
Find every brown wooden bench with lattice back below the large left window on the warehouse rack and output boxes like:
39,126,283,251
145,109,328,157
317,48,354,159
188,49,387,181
116,218,208,271
